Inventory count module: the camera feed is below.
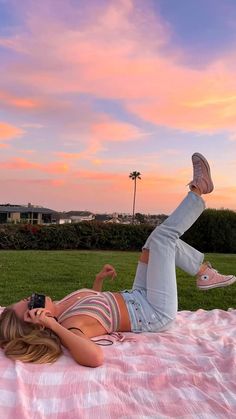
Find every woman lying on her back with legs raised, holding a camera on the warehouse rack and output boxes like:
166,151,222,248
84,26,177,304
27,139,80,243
0,153,236,367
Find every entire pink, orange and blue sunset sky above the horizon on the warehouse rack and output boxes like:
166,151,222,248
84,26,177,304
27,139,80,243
0,0,236,214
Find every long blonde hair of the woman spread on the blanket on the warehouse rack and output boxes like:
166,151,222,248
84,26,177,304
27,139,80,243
0,307,62,364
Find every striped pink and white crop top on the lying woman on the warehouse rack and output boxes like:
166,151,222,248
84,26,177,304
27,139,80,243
57,288,120,333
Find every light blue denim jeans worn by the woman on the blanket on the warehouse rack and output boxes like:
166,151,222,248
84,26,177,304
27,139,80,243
121,192,205,333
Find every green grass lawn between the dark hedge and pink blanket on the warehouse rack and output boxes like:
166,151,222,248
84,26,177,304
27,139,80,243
0,250,236,310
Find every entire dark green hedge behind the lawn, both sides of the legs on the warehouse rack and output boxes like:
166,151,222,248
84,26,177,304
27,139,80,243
0,209,236,253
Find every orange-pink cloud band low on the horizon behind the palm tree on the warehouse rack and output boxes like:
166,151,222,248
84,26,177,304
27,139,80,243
1,171,236,214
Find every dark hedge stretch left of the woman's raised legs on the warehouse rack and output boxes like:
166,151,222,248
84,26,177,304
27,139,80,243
0,221,152,250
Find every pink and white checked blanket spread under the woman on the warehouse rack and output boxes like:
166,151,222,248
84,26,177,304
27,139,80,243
0,310,236,419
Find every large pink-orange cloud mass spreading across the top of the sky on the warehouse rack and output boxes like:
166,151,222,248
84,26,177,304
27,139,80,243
2,0,236,138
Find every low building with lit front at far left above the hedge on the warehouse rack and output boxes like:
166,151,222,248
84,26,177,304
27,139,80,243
0,203,57,224
